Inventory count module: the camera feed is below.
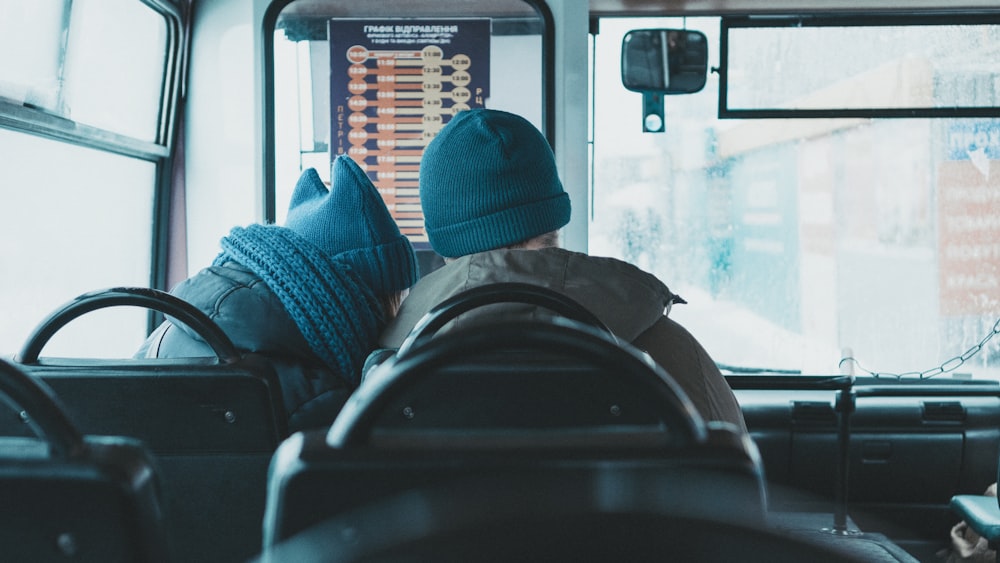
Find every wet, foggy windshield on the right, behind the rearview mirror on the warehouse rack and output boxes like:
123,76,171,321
589,18,1000,379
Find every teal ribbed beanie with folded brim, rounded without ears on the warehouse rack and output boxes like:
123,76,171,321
420,109,570,258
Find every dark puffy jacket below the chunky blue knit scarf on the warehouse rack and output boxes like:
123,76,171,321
137,262,356,432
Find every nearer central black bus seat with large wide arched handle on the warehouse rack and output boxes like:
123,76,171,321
264,318,766,548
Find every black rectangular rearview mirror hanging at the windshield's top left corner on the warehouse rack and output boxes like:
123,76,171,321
622,29,708,94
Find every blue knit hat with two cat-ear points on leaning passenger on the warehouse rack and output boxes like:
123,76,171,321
285,155,419,295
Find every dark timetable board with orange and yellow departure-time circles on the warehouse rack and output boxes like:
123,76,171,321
329,18,490,248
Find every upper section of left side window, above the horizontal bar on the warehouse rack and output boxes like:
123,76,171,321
0,0,167,142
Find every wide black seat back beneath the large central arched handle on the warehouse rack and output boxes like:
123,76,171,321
264,428,766,550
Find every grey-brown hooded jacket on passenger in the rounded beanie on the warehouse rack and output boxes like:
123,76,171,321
379,248,746,432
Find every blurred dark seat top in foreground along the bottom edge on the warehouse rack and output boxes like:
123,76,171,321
255,467,867,563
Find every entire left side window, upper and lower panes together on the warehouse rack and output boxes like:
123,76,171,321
0,0,179,357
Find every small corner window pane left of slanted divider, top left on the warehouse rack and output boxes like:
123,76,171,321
0,0,67,111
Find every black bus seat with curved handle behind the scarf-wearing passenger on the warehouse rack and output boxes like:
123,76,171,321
9,287,287,562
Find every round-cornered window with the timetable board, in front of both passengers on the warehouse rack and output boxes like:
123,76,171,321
267,0,545,251
